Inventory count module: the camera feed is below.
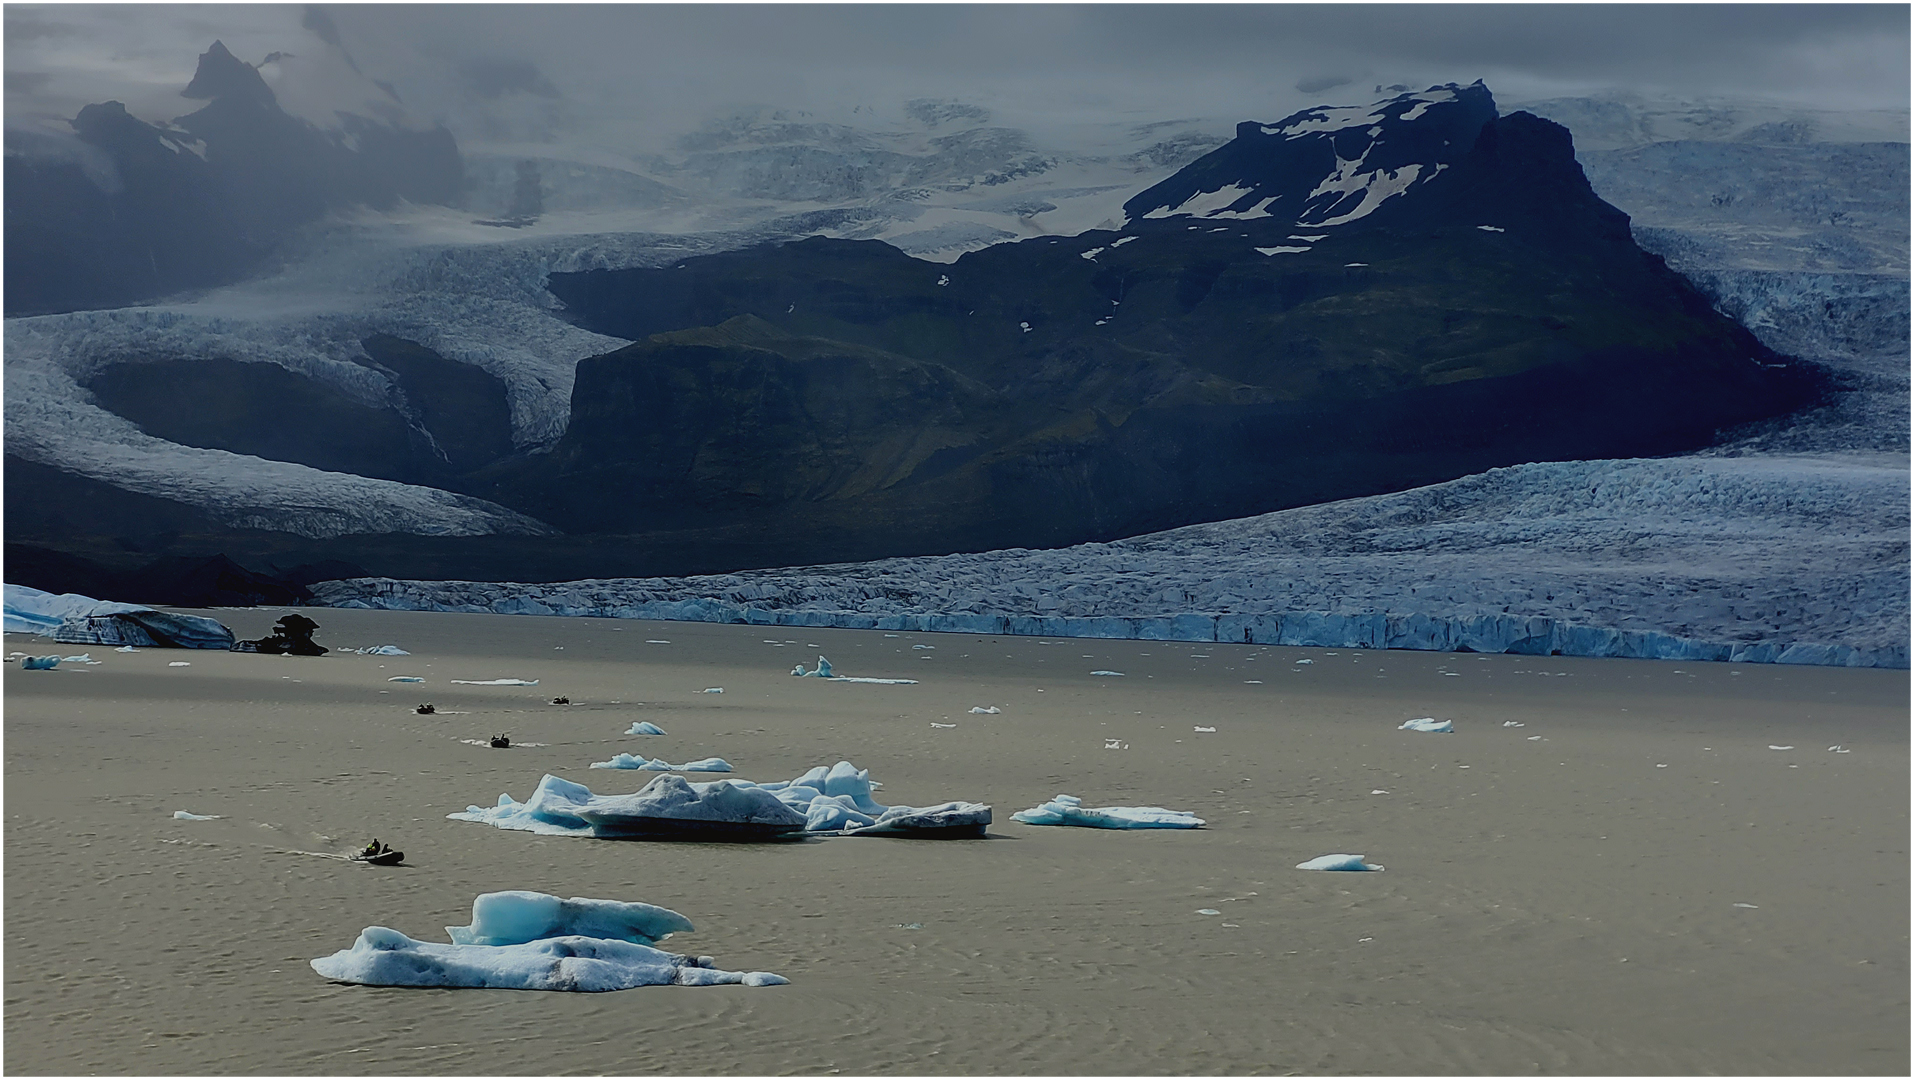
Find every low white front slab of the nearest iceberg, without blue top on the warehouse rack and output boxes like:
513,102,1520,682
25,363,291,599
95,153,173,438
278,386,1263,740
312,927,789,994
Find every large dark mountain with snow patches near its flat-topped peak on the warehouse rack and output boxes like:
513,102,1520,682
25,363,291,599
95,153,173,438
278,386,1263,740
520,86,1816,559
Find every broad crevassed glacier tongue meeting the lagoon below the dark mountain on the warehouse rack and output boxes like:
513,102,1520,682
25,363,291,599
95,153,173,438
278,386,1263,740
314,452,1908,666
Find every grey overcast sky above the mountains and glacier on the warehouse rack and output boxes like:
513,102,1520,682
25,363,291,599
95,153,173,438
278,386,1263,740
6,4,1908,147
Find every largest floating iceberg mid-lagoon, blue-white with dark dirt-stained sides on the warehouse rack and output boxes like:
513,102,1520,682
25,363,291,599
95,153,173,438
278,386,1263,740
448,758,990,839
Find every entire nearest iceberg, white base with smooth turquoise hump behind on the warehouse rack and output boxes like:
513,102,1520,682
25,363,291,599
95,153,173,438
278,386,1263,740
312,892,790,994
